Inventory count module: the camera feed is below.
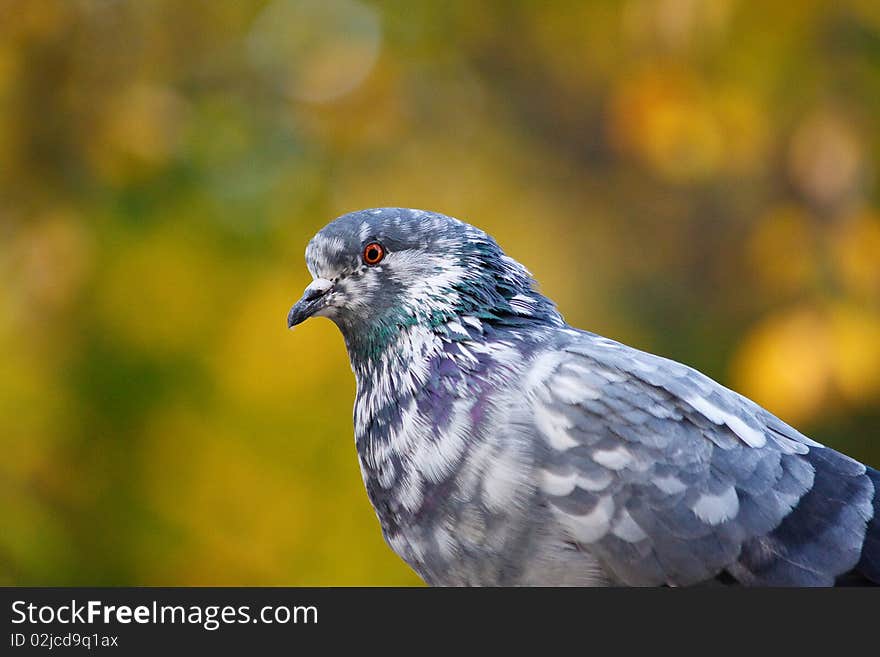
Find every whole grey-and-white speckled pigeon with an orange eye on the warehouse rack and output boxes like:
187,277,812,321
287,208,880,586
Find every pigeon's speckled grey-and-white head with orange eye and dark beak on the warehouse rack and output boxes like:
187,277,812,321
287,208,561,348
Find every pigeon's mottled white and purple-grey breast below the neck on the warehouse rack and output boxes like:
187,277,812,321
355,326,544,584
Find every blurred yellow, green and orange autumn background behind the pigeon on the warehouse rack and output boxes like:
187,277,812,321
0,0,880,585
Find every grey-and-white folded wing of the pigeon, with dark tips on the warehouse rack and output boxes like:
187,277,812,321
526,331,880,586
